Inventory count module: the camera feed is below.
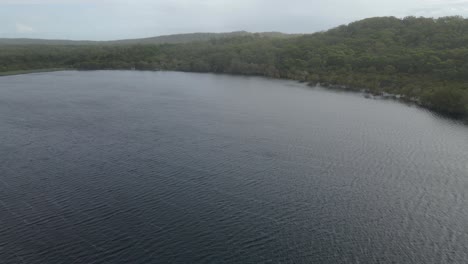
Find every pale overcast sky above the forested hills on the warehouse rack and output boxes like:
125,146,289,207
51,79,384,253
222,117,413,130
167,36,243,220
0,0,468,40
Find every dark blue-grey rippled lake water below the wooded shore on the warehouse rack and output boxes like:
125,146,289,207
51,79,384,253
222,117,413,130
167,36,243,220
0,71,468,264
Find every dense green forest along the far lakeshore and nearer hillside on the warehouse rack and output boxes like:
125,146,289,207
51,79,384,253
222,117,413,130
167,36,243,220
0,17,468,117
